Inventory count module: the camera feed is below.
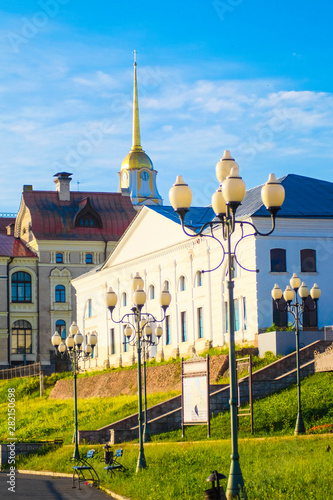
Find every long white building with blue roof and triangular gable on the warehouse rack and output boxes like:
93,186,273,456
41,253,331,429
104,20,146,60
72,175,333,366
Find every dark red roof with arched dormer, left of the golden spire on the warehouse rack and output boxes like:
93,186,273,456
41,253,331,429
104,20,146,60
22,191,137,241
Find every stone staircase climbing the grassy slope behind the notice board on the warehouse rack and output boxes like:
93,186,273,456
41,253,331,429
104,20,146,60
79,340,332,444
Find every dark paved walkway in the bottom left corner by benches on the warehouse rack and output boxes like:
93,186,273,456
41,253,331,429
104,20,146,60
0,471,115,500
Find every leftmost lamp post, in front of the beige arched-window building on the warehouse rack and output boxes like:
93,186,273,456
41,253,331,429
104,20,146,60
51,321,97,460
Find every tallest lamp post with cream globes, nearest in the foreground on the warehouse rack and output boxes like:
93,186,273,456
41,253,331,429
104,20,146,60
169,150,285,500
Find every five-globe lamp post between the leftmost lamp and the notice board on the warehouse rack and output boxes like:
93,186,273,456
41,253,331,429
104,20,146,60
106,273,171,472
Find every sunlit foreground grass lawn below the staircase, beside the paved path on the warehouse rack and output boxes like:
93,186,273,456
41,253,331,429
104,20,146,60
17,435,333,500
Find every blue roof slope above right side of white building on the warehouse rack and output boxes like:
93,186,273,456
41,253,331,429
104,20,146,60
236,174,333,219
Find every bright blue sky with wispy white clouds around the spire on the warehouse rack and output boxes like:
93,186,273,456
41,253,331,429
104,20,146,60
0,0,333,212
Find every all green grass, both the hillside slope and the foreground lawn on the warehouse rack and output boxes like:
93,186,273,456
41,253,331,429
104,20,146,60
0,373,333,500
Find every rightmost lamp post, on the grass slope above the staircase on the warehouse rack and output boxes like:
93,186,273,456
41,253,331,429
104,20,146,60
272,273,321,435
